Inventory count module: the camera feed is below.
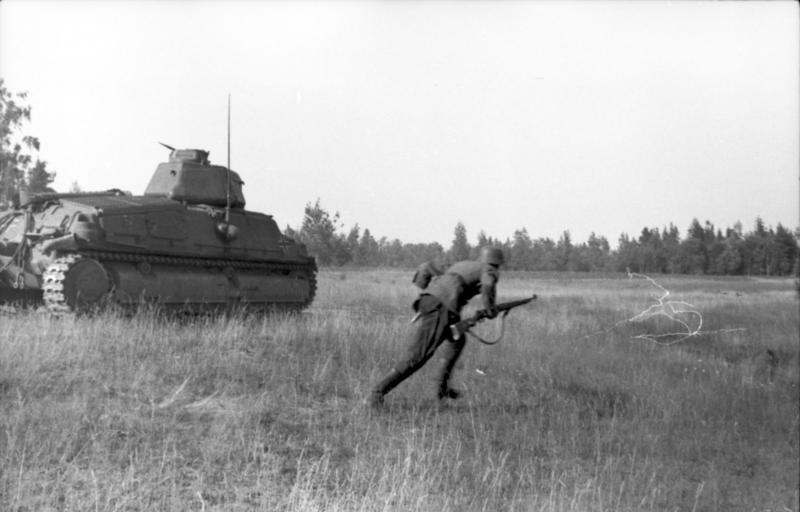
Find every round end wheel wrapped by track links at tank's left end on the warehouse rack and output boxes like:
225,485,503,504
43,254,111,314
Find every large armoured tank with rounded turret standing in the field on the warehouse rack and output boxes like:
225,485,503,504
0,148,317,313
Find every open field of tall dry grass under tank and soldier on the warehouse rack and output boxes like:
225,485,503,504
0,270,800,512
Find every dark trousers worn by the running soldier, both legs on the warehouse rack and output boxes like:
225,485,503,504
374,295,466,396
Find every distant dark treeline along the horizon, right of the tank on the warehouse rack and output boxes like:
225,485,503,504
286,199,800,276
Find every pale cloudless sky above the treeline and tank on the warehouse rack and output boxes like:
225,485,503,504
0,0,800,247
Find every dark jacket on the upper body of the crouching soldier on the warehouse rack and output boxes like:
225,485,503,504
423,261,500,313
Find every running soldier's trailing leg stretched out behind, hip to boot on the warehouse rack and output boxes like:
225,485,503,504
369,296,448,407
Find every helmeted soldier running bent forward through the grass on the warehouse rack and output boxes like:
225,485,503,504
368,247,503,409
